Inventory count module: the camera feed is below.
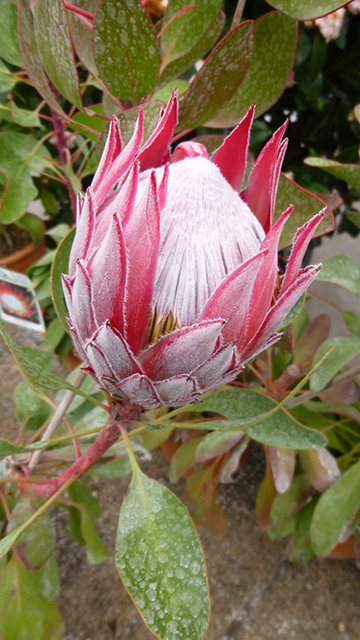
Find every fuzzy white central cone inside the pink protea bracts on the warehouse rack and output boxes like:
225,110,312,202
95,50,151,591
153,157,265,326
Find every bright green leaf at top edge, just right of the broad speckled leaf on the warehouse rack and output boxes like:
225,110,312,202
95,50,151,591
161,0,222,67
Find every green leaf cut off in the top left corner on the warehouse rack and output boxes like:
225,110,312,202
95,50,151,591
0,0,23,67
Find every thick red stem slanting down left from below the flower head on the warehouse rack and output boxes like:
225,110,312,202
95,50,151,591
32,421,120,500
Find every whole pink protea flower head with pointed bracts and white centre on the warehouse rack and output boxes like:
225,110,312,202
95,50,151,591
63,90,324,408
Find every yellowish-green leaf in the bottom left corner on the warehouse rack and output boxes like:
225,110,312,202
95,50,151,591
0,556,64,640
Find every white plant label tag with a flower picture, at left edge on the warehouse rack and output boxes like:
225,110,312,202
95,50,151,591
0,267,45,333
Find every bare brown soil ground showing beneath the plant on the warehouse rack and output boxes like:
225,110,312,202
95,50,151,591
0,325,360,640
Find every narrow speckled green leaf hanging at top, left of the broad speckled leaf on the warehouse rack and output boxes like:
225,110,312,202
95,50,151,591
33,0,83,111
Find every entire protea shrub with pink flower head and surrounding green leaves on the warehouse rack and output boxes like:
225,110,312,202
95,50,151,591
0,0,360,640
